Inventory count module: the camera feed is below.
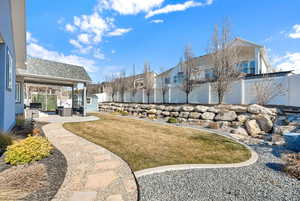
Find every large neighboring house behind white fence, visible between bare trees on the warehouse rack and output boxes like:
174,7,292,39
157,38,271,86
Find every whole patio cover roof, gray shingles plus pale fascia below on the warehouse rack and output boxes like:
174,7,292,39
17,57,92,85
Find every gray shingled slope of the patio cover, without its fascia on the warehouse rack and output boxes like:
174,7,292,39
17,57,92,82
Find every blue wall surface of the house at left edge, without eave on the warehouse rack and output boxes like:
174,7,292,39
0,0,16,131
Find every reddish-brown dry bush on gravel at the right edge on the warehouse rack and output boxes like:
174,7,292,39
283,153,300,180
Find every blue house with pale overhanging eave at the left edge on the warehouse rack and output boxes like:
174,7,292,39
0,0,26,131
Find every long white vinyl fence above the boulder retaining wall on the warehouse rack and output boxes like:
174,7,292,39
98,75,300,107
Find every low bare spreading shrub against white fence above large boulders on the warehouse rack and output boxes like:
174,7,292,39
254,74,287,105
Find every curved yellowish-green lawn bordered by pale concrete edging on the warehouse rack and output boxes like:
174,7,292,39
64,113,251,171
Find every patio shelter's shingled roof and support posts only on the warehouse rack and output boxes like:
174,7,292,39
17,58,91,116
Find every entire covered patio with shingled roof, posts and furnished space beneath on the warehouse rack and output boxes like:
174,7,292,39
16,58,91,117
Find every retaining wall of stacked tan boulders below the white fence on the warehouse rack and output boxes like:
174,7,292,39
99,103,300,141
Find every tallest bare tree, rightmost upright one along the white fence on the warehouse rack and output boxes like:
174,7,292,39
208,22,241,104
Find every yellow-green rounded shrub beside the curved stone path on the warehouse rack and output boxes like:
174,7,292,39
4,136,53,165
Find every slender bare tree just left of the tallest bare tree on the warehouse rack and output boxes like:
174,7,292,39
180,46,196,103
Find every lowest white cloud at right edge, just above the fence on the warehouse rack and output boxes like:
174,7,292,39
272,52,300,73
